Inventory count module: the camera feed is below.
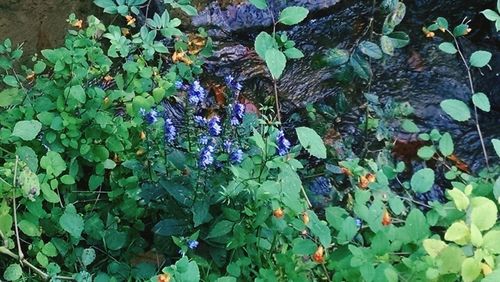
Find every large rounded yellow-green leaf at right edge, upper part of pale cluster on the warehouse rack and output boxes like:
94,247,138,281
470,197,498,231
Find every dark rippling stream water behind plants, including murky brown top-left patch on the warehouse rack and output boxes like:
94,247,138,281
0,0,500,169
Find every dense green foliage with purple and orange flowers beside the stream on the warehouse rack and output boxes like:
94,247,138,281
0,0,500,281
